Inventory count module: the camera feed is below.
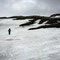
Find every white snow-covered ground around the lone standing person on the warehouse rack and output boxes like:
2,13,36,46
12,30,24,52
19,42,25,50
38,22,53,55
0,19,60,60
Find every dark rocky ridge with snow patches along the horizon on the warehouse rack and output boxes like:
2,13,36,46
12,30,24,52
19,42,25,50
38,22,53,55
0,14,60,30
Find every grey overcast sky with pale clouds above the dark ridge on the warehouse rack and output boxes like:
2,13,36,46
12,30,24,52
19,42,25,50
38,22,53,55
0,0,60,16
